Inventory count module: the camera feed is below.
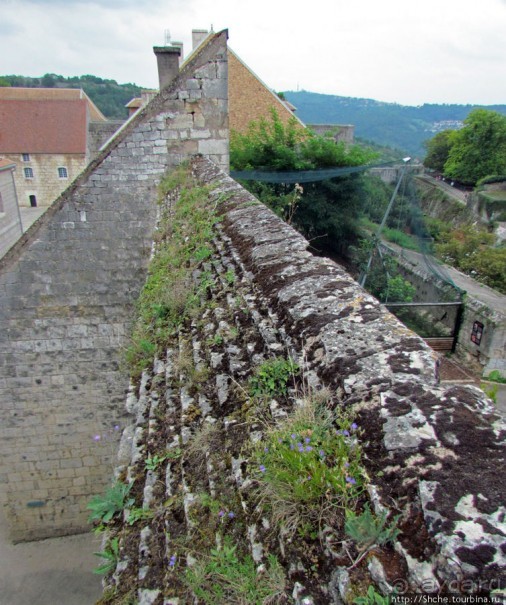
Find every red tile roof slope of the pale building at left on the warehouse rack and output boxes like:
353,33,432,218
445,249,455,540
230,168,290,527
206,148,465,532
0,98,88,153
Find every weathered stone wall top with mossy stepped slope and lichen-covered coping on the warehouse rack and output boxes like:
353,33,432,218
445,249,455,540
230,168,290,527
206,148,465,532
104,158,506,604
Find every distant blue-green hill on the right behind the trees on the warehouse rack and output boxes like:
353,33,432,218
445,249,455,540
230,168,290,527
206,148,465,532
284,90,506,158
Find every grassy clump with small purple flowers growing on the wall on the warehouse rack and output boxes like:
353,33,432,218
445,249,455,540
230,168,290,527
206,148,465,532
251,399,366,534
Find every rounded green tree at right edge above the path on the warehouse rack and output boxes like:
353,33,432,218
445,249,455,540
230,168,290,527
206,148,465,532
444,109,506,185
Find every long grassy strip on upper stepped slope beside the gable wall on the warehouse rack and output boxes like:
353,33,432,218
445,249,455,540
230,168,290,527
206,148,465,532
125,166,218,379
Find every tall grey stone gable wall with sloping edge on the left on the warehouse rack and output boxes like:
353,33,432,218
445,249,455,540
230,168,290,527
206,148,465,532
0,32,228,540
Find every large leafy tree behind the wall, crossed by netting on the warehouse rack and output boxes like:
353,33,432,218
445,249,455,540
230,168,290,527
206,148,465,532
230,110,375,249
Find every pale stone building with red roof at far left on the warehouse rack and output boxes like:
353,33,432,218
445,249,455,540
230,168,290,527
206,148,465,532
0,87,107,207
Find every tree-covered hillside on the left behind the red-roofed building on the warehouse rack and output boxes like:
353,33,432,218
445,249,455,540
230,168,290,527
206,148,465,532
0,74,142,120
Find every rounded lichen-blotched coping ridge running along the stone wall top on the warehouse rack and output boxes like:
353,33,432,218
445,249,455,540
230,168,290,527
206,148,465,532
194,159,506,582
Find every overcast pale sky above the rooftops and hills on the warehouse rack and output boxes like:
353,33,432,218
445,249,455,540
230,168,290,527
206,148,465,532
0,0,506,105
